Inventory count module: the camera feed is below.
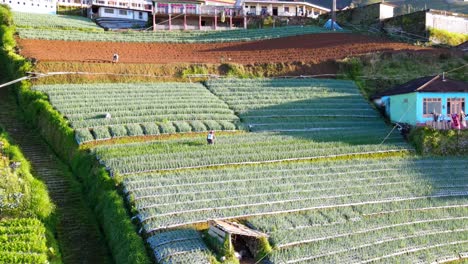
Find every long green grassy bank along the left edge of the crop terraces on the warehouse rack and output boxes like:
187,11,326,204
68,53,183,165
0,6,150,263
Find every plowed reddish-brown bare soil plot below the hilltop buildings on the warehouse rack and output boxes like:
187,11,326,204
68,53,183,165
18,33,436,64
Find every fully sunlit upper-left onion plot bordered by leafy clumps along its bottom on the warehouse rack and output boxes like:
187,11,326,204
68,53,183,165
34,83,238,143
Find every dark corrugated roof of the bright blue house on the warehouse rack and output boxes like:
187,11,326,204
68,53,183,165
372,75,468,98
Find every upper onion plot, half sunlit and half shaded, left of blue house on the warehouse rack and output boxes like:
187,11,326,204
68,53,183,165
207,79,384,132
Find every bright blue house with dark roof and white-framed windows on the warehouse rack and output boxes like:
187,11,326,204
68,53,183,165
372,75,468,125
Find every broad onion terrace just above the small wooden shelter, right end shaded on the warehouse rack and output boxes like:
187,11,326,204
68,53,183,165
115,159,468,232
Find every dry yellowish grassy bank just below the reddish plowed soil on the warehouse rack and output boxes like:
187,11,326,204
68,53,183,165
34,61,338,84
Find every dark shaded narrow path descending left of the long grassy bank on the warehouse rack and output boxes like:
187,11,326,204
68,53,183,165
0,88,111,264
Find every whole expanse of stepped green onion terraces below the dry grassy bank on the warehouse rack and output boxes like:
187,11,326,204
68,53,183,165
31,75,468,263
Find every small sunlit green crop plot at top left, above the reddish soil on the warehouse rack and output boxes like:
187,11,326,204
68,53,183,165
13,12,104,31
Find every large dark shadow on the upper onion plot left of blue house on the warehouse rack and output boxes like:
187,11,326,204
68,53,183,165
232,90,403,145
